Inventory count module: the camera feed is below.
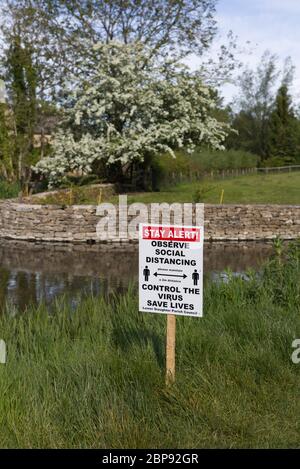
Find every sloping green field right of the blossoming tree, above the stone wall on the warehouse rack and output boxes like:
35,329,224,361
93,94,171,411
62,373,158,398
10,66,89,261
113,172,300,205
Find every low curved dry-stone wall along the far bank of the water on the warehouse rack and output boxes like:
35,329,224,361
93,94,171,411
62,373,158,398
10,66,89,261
0,201,300,243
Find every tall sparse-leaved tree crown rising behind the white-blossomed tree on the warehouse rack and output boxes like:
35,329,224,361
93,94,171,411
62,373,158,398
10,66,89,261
0,0,216,101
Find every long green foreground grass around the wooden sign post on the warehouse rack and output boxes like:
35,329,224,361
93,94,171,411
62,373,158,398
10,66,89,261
0,239,300,448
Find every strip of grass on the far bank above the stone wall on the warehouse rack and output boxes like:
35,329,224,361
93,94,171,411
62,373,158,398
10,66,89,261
26,172,300,205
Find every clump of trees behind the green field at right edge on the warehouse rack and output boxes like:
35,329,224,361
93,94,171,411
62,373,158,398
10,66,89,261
226,51,300,160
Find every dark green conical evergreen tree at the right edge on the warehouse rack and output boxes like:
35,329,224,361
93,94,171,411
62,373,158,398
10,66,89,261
269,84,300,162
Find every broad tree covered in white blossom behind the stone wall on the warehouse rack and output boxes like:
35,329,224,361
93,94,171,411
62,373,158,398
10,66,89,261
37,42,229,184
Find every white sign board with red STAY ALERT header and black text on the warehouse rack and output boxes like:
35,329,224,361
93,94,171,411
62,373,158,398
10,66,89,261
139,224,204,317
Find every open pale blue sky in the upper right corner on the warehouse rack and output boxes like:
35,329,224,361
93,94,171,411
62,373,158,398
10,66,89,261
191,0,300,101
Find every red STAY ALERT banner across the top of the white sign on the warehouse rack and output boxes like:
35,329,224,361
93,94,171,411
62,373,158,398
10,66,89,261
142,225,200,243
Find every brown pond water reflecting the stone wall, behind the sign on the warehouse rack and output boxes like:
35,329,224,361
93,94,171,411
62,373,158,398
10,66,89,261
0,240,272,311
